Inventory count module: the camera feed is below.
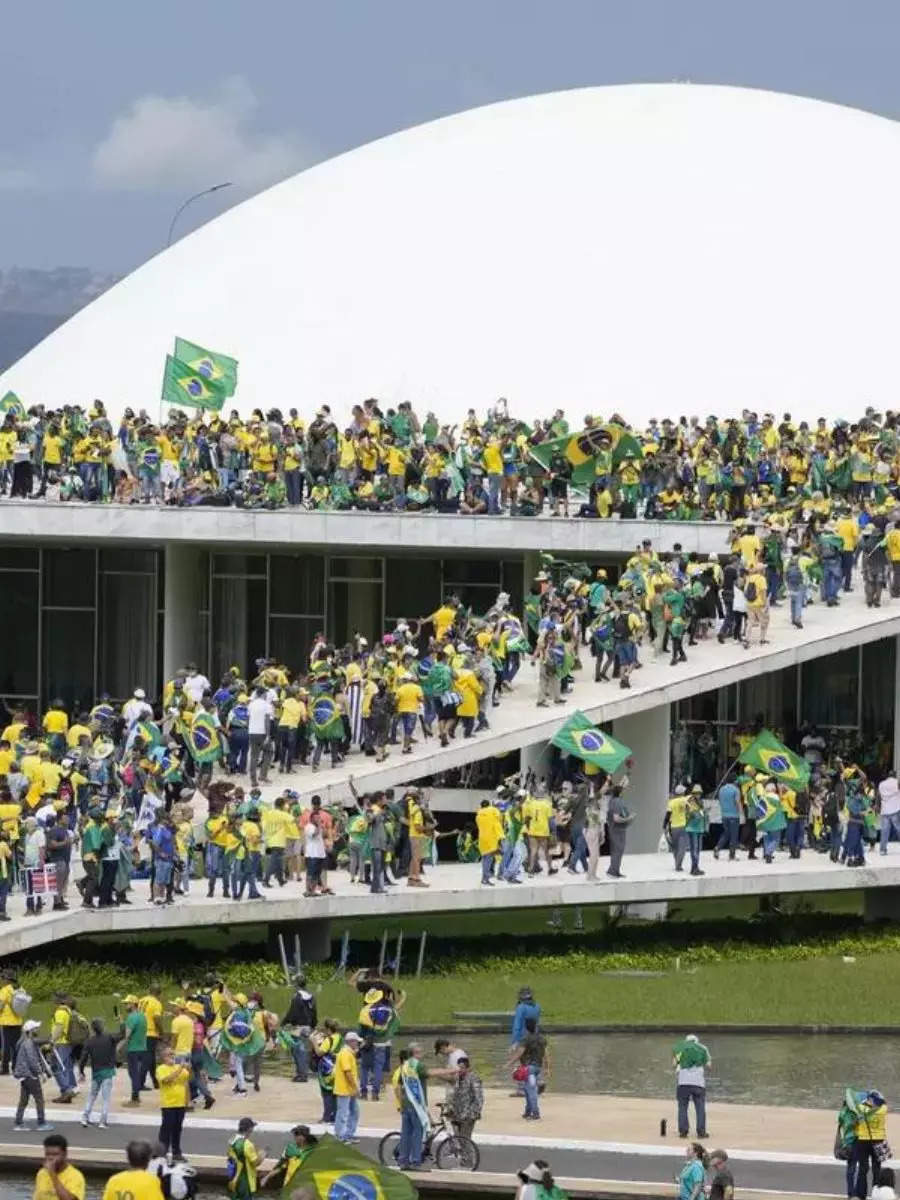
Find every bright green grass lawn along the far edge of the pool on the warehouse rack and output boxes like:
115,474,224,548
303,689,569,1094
19,954,900,1026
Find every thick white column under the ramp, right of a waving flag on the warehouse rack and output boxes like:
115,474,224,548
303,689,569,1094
612,704,670,854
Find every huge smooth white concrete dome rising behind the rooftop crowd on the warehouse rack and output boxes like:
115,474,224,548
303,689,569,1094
0,84,900,421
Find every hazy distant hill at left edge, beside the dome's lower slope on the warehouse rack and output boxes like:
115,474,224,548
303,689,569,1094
0,266,119,371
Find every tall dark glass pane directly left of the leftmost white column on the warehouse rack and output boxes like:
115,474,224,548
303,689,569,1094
98,575,157,700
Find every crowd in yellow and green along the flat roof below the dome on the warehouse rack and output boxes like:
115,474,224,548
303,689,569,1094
0,400,900,521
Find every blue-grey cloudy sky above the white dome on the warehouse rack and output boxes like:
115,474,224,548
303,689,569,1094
0,0,900,271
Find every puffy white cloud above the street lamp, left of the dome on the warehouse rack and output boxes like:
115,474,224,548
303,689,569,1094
92,78,313,191
